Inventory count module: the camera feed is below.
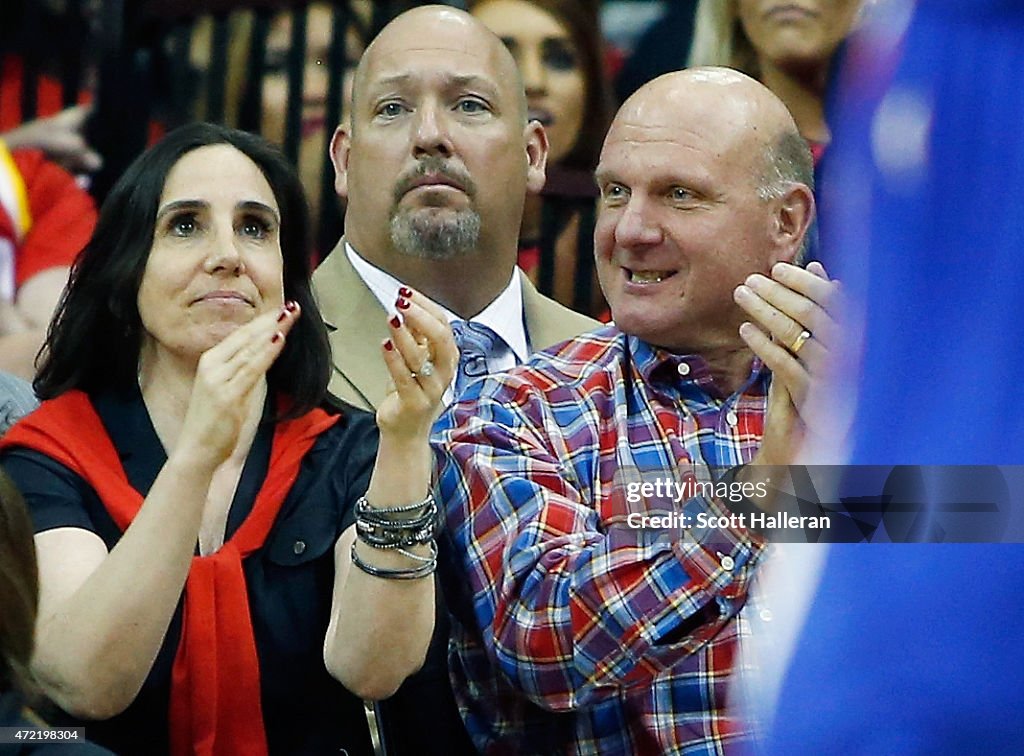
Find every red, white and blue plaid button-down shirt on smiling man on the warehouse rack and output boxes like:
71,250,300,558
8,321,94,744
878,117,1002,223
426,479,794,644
435,327,769,756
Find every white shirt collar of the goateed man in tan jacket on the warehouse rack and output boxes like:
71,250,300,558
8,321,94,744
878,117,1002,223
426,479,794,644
345,241,529,363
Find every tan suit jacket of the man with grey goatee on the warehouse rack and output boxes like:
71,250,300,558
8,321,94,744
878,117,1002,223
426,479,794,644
313,239,601,405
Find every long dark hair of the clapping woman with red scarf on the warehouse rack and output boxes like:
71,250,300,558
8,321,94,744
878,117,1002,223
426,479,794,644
33,123,331,416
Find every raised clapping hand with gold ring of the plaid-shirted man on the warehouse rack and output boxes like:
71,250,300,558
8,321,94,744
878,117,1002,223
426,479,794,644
734,256,842,464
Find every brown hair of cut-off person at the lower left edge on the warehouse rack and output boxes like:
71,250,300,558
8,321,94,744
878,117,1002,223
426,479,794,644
0,469,39,697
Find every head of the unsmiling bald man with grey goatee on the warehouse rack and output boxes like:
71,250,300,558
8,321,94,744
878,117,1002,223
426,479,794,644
331,5,547,317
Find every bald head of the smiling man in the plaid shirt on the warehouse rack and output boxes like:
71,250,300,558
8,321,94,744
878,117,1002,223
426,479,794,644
594,68,814,352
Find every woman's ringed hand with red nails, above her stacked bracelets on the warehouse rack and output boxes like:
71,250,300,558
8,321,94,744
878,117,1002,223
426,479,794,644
377,287,459,439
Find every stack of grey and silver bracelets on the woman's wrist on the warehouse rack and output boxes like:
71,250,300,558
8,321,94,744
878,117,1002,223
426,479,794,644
352,494,440,580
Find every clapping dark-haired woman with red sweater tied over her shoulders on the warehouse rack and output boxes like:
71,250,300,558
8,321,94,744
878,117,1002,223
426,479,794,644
2,124,457,754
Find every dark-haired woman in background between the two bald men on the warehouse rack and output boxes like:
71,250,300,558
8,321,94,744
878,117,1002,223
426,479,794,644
469,0,611,312
